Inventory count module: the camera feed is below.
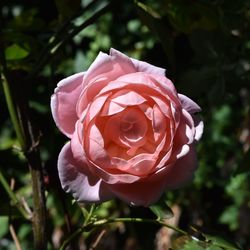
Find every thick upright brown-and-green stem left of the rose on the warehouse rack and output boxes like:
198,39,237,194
0,29,47,250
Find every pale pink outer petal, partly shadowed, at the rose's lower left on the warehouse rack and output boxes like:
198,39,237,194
58,142,112,202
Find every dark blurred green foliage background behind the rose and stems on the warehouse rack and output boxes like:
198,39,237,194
0,0,250,250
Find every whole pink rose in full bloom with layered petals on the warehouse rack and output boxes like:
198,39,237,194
51,49,203,206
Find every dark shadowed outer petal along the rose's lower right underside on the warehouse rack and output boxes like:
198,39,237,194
110,145,197,206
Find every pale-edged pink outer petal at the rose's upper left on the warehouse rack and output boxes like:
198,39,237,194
50,72,84,138
